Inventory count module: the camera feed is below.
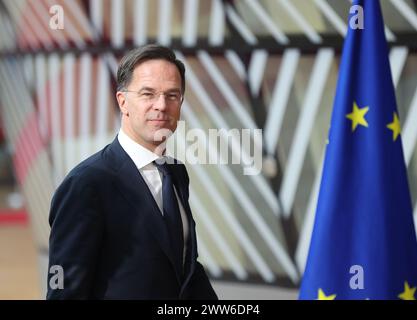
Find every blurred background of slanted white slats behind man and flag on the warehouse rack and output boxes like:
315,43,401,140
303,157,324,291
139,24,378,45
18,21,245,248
0,0,417,299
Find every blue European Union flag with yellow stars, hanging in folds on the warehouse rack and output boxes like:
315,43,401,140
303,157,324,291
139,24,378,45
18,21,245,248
300,0,417,300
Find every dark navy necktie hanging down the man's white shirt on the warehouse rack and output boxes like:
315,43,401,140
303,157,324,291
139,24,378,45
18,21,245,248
154,161,184,272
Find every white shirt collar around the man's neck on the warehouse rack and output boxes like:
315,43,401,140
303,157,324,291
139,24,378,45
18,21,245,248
117,129,160,169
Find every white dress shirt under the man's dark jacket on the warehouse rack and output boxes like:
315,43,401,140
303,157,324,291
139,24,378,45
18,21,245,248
117,129,189,262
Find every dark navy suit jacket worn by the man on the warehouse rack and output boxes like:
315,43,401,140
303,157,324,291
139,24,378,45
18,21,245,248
47,138,217,299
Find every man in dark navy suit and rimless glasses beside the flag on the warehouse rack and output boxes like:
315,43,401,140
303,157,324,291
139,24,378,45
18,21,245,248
47,45,217,299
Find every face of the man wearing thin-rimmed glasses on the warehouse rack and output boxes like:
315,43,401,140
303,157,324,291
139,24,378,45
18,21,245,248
116,60,182,150
